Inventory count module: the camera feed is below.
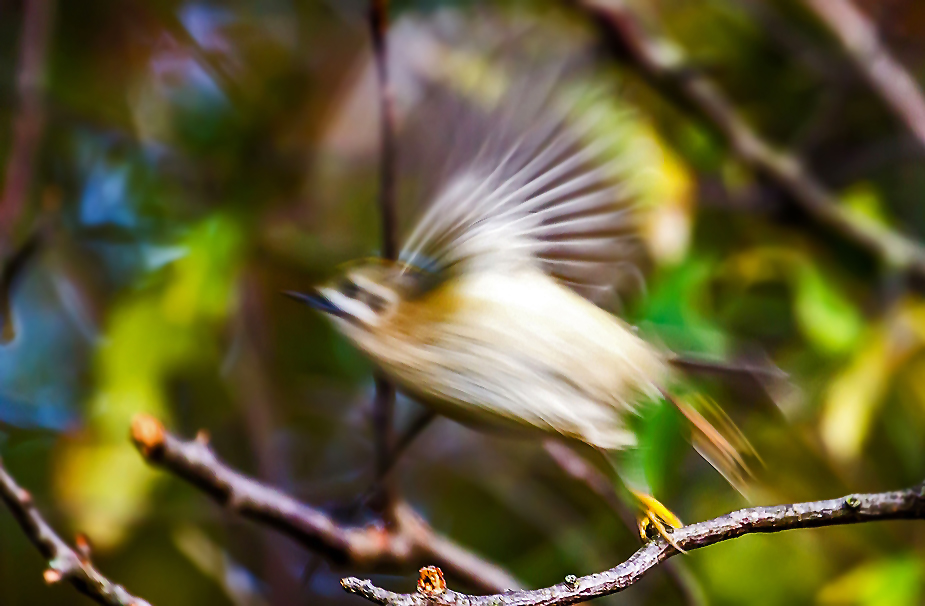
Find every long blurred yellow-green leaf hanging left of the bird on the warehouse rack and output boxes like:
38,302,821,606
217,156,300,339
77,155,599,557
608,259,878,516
56,217,240,548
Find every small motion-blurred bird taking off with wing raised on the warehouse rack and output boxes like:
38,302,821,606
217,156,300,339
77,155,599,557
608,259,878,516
288,55,745,551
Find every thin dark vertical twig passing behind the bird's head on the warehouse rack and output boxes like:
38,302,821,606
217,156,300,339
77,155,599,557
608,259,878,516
369,0,398,522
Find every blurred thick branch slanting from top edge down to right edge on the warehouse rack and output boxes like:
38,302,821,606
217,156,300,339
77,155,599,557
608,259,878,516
567,0,925,280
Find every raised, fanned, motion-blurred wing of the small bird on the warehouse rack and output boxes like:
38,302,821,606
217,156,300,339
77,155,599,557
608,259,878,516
401,71,642,302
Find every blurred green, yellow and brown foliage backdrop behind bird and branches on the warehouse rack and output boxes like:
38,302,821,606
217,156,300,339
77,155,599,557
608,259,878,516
0,0,925,606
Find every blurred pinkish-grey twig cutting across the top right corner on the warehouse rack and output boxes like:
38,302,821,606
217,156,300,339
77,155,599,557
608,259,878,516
803,0,925,151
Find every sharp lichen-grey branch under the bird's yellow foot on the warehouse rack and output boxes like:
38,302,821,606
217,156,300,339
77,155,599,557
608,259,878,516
341,483,925,606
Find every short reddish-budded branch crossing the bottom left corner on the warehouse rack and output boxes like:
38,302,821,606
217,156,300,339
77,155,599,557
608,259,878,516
0,464,151,606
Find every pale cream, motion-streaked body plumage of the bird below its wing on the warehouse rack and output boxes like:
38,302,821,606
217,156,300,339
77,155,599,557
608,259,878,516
378,270,666,449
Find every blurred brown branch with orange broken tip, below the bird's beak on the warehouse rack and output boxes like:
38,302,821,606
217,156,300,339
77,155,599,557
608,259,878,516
132,415,520,591
